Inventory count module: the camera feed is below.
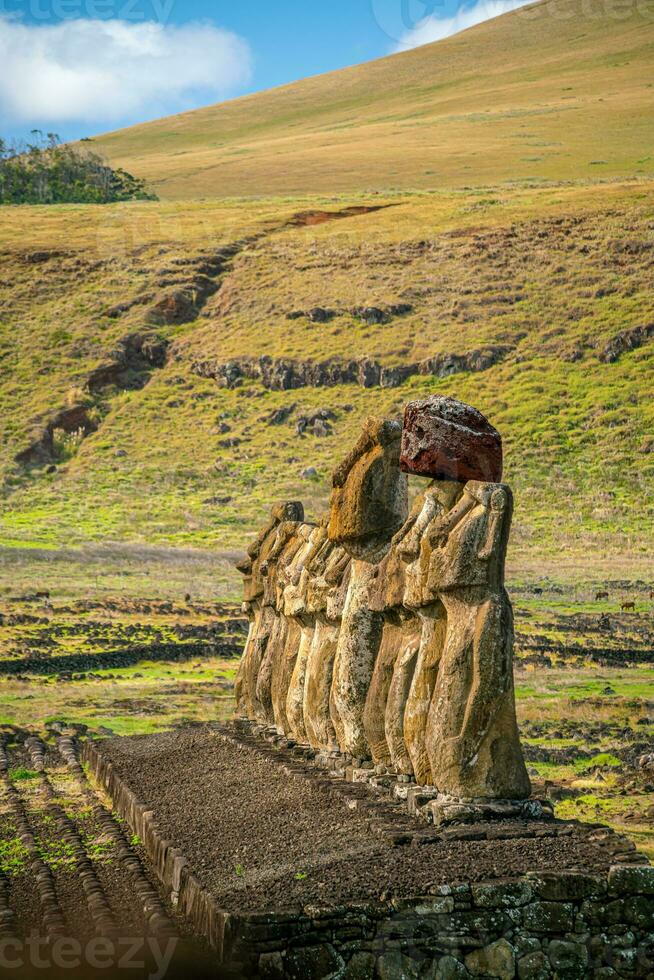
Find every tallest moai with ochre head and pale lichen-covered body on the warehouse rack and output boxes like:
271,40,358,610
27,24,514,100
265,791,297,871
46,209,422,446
329,418,408,759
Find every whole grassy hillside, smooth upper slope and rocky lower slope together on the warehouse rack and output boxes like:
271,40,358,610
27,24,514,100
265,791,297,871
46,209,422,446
0,0,654,595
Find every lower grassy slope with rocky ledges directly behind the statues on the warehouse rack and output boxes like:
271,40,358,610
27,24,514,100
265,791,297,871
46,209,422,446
0,182,654,594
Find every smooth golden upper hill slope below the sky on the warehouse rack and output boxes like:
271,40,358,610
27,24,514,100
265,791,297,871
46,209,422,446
93,0,654,199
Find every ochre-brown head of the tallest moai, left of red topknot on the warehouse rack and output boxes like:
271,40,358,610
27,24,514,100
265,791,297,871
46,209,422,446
329,418,408,562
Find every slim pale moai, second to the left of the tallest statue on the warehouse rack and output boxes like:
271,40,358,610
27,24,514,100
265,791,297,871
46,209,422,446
284,520,329,743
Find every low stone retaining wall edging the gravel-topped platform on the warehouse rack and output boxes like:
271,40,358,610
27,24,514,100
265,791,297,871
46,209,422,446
83,742,654,980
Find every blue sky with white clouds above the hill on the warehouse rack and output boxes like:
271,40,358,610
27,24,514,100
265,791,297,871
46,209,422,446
0,0,523,138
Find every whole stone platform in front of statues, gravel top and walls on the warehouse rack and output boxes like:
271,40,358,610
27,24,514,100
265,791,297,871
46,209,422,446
84,724,654,980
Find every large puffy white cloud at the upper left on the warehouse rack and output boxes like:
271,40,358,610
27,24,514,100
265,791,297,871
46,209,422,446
0,16,251,125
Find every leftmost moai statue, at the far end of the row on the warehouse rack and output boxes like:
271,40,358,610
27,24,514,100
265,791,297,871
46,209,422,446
235,501,304,720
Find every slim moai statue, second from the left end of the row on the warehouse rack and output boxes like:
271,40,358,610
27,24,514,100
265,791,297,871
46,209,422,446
255,521,305,725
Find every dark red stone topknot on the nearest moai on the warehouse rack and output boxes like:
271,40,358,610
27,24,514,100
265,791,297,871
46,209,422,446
400,395,502,483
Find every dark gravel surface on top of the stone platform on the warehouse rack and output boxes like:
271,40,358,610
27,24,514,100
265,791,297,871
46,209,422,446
98,727,610,911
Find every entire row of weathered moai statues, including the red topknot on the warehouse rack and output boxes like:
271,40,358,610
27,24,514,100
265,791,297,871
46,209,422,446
236,397,530,801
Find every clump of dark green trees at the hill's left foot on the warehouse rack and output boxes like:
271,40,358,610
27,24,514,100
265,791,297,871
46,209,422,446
0,129,156,204
